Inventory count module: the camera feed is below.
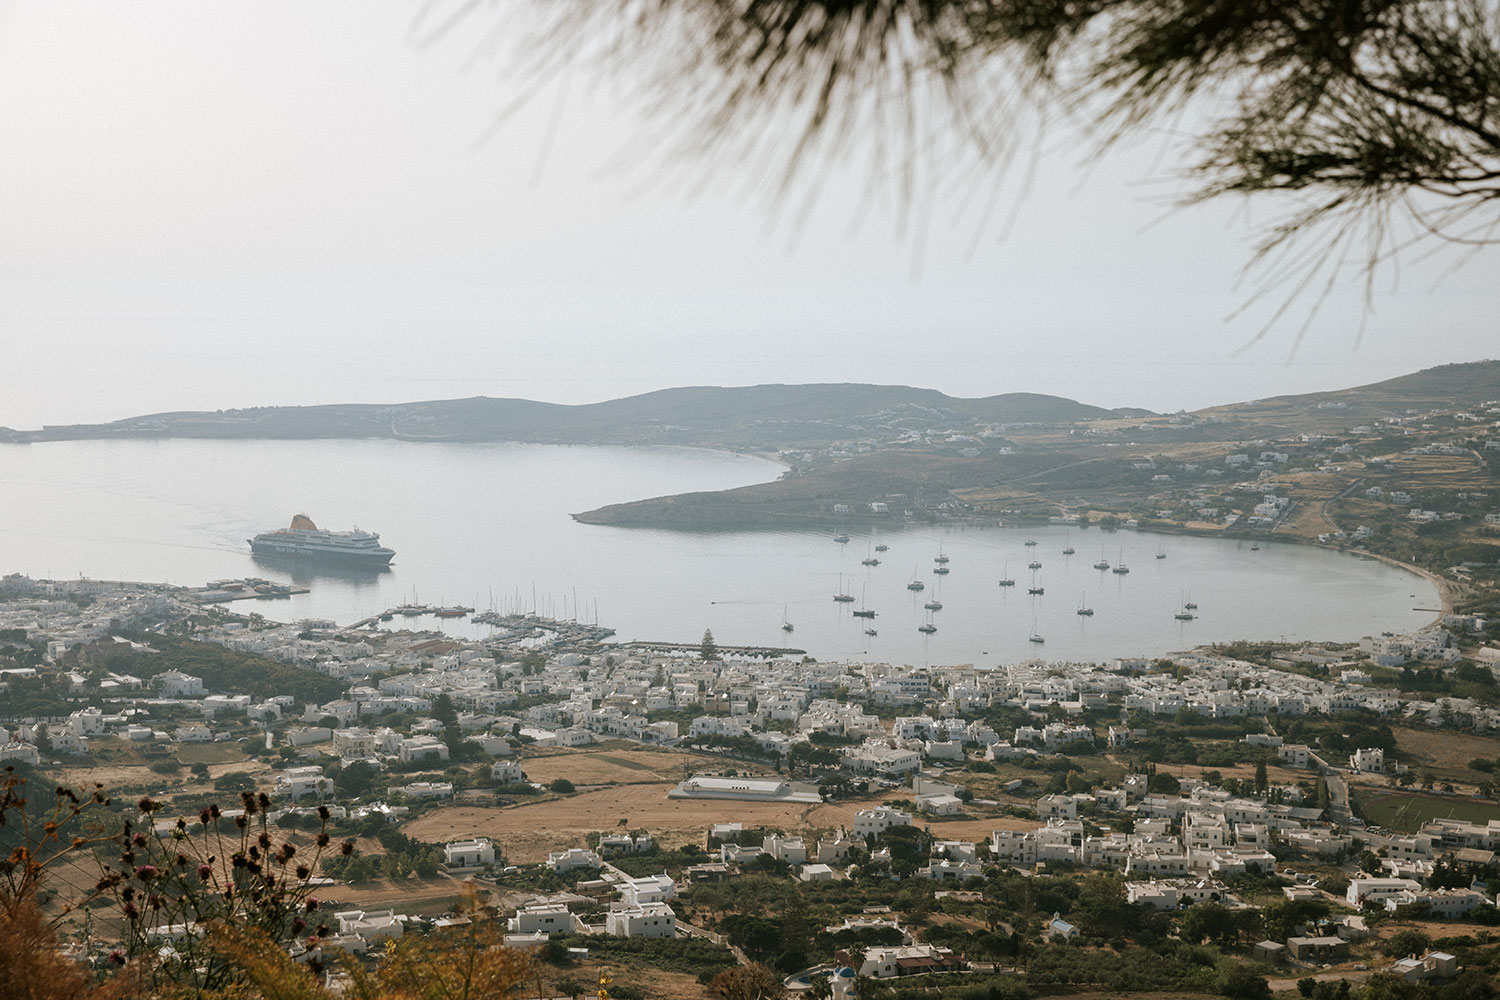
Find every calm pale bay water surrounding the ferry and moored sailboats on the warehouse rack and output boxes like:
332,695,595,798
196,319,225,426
0,441,1439,664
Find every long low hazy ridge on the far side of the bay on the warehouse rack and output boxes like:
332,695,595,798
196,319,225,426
0,384,1124,448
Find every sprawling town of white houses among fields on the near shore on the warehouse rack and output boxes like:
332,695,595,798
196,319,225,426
0,576,1500,993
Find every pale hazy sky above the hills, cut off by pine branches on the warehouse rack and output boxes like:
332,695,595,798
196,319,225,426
0,0,1500,427
